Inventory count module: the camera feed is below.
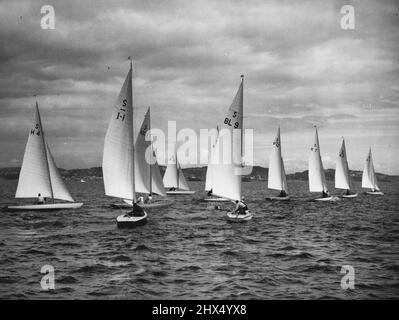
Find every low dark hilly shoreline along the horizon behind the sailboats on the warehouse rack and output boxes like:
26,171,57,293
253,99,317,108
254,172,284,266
0,166,399,182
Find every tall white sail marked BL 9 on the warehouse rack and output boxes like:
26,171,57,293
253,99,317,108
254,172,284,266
212,79,244,200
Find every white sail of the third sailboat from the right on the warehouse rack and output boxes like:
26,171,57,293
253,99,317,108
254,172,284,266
308,128,328,192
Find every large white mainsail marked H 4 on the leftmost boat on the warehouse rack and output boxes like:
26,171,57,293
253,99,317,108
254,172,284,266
15,102,52,198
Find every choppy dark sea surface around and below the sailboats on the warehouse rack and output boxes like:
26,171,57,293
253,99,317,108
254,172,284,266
0,179,399,300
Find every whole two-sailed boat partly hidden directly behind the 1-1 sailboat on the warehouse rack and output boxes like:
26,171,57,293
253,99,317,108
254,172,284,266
111,107,173,209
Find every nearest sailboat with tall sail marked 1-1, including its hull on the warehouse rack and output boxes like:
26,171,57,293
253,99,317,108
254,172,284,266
102,62,148,228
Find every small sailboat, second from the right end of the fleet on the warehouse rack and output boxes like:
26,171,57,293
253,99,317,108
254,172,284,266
335,138,357,198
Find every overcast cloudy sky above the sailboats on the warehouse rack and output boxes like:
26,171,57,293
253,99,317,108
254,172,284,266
0,0,399,174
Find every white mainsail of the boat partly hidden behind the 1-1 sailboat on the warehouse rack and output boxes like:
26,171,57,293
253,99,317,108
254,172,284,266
134,109,152,193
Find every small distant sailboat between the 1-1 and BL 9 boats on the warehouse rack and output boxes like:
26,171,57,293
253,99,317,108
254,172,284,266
163,143,195,195
